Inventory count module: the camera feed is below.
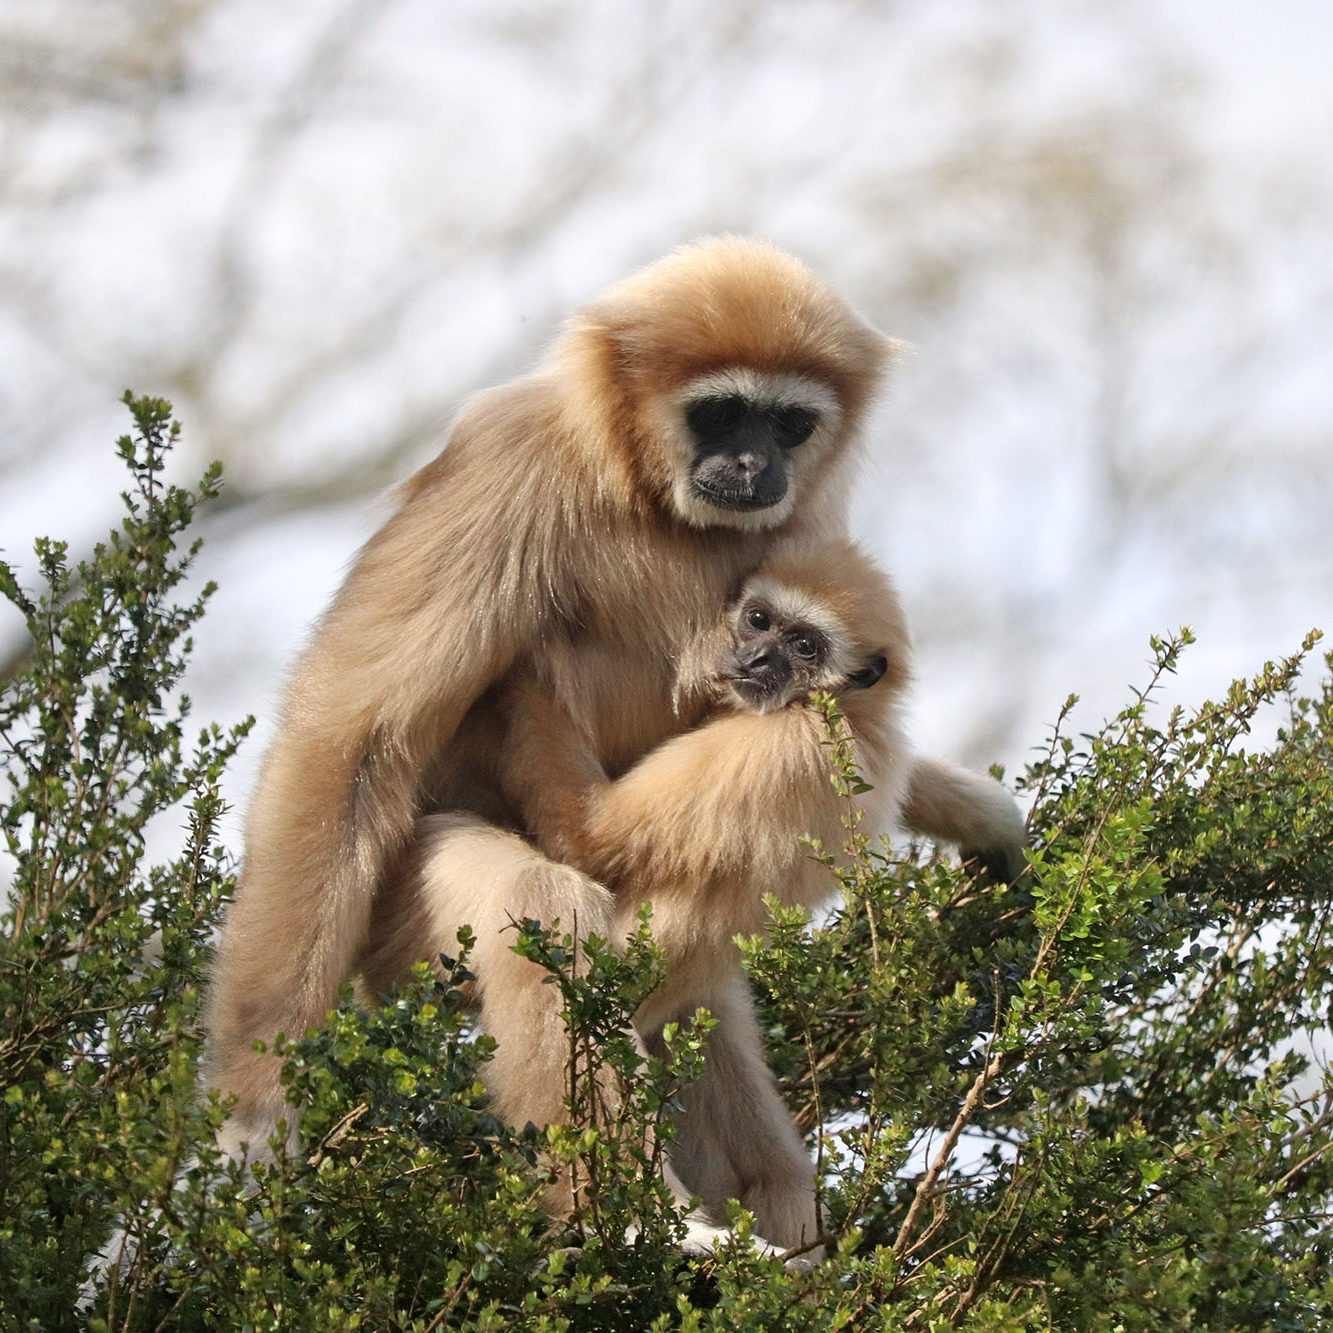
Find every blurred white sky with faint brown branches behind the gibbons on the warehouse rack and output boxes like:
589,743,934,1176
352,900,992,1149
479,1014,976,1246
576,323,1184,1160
0,0,1333,841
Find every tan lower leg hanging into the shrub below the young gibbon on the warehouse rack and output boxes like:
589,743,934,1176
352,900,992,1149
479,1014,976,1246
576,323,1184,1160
649,972,818,1257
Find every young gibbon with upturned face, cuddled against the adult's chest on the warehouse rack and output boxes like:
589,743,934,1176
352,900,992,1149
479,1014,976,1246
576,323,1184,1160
445,541,1024,1248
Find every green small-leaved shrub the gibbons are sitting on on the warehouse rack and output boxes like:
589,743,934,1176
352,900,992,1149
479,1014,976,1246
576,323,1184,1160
0,396,1333,1333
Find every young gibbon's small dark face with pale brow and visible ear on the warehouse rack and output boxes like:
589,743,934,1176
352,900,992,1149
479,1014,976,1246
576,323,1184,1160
718,576,888,713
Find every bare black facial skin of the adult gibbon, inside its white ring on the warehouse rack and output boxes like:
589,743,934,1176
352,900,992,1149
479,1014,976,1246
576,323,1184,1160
685,392,820,513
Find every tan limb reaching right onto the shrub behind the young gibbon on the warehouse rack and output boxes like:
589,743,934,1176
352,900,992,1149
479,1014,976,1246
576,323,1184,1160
902,754,1028,884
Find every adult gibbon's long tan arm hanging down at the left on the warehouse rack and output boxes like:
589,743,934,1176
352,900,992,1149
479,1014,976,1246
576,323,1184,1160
209,384,571,1122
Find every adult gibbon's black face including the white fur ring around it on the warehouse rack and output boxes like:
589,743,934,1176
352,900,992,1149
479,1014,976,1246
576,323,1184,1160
667,367,841,528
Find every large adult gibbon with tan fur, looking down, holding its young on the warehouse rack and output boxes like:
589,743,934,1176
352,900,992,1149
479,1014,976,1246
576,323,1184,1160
207,239,892,1154
